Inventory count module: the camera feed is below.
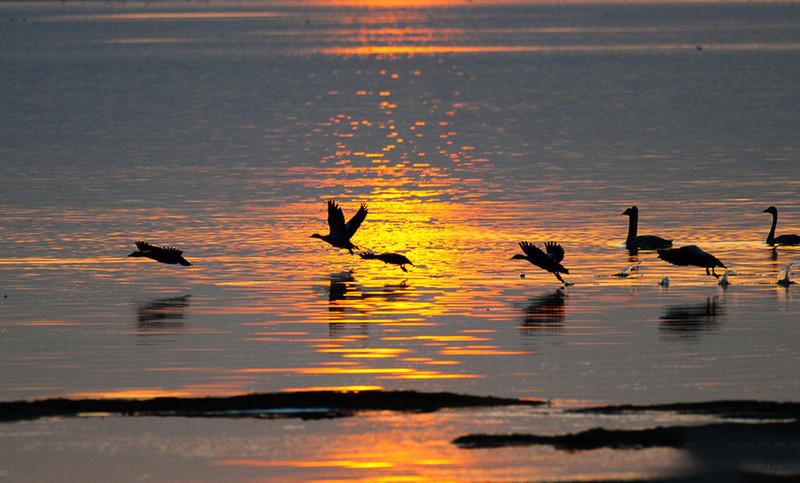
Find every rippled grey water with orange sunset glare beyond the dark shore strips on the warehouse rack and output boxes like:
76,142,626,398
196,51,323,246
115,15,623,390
0,2,800,478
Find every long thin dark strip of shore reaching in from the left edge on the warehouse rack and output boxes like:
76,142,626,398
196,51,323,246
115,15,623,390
0,391,543,422
